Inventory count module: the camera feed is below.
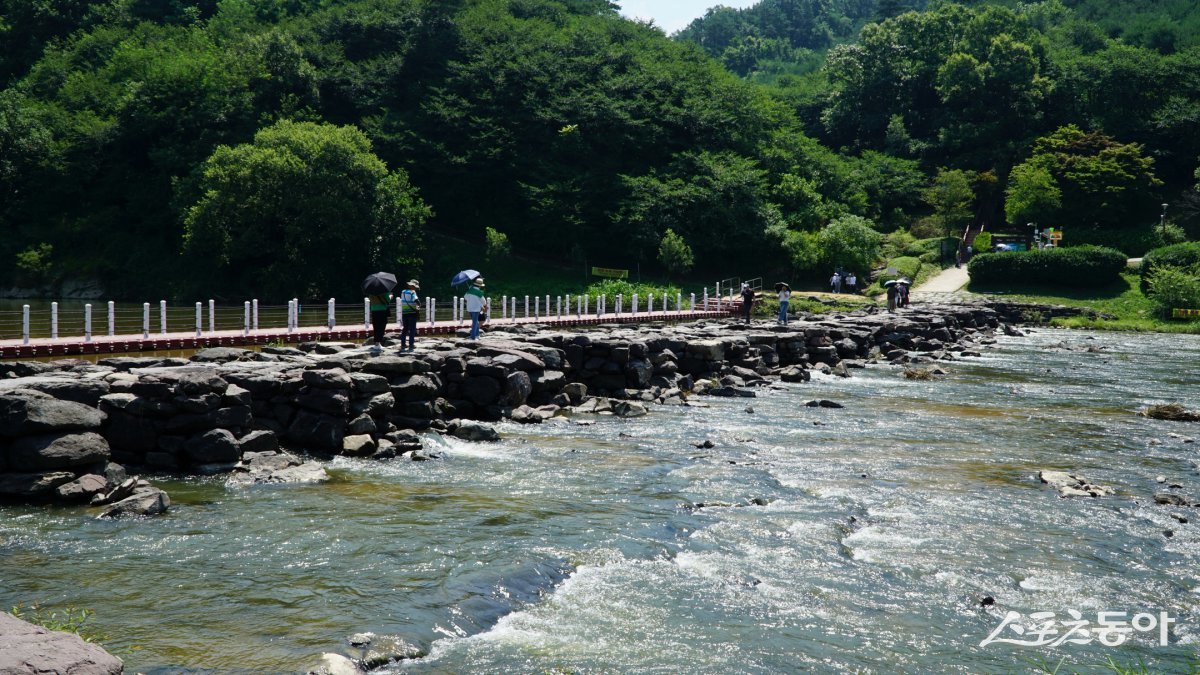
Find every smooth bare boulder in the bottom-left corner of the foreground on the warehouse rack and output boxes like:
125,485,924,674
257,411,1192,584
0,613,125,675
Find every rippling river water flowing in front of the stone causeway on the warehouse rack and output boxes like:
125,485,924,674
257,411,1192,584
0,330,1200,674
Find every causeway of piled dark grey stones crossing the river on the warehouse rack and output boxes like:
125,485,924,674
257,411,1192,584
0,305,1051,518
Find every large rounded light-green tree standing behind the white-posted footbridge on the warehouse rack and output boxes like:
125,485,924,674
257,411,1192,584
184,121,430,299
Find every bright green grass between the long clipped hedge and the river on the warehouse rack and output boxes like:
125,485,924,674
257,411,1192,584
967,271,1200,334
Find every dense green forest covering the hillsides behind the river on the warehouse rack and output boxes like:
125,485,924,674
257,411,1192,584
0,0,1200,298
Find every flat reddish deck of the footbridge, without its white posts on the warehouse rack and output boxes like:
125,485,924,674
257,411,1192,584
0,301,740,359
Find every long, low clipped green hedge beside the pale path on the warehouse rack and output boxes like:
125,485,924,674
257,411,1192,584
967,246,1127,286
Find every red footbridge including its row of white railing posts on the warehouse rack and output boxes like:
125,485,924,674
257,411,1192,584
0,291,742,359
